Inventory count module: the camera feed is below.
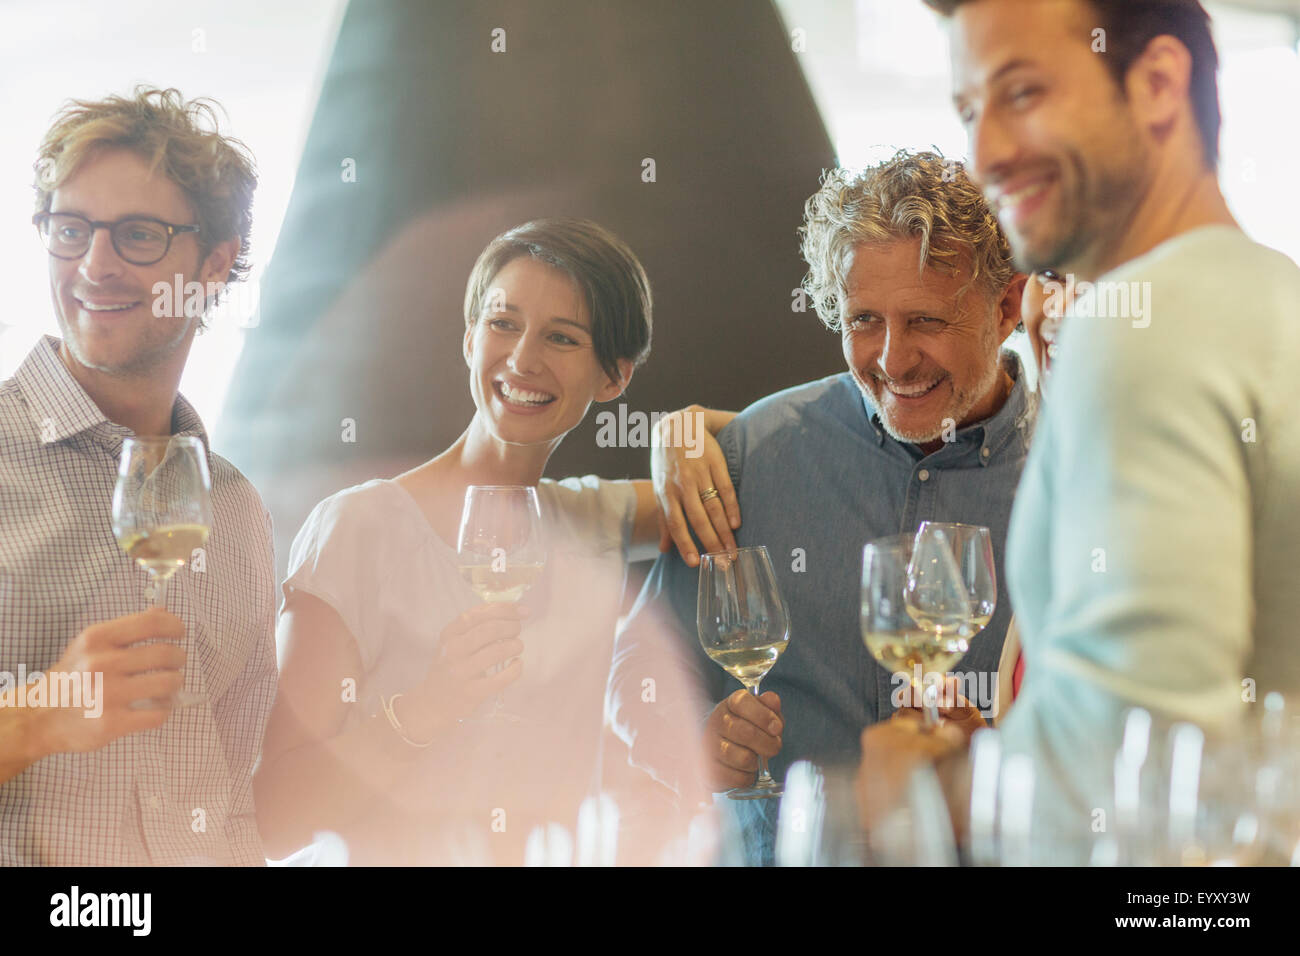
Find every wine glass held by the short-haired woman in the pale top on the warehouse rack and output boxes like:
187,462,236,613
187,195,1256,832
456,485,546,722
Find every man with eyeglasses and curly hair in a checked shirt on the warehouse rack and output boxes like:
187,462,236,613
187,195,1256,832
0,88,276,865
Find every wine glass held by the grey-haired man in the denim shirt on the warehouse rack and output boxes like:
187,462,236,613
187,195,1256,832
696,545,790,800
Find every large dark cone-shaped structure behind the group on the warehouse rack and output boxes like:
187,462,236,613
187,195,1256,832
216,0,842,571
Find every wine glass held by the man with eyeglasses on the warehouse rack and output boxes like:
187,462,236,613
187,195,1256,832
112,436,212,706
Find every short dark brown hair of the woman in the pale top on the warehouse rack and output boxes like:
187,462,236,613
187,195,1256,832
465,216,653,381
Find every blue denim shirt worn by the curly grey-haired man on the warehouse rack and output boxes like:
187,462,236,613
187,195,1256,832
607,352,1035,832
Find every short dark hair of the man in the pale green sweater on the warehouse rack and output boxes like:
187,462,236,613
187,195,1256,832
923,0,1223,169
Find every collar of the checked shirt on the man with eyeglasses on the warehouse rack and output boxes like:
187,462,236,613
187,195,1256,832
13,336,212,454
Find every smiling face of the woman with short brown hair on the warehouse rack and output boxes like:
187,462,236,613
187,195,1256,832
465,256,632,445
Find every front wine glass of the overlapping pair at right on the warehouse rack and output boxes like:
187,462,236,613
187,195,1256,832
861,535,966,726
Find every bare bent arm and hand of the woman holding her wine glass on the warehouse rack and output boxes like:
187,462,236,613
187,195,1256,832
254,591,524,858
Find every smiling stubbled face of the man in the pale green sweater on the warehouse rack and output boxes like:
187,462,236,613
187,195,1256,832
952,0,1148,273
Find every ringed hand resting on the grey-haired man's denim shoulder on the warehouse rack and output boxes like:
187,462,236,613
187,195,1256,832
650,405,740,567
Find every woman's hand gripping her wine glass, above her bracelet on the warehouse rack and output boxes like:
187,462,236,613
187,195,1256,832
394,602,528,741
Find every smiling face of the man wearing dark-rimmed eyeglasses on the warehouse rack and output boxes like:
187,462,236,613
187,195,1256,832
49,150,229,376
